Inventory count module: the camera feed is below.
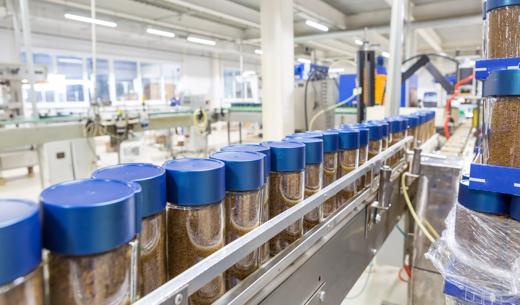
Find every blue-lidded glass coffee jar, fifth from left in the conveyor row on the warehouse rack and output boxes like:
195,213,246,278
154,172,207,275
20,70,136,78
210,151,265,289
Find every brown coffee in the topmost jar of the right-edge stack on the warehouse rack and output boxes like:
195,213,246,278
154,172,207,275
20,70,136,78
487,5,520,58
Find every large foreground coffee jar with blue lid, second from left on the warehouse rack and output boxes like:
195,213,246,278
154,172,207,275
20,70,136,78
40,179,141,305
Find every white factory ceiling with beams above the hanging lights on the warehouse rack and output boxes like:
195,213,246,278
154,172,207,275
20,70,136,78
0,0,482,58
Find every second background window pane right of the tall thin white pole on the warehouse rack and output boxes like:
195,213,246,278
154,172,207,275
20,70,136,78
114,60,139,101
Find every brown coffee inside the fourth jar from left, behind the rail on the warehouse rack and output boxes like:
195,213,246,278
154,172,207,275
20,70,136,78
167,203,226,305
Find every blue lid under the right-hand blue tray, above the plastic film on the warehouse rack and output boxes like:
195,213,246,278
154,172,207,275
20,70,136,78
459,179,509,215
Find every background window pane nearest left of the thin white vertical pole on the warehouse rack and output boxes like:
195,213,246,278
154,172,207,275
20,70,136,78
56,56,85,102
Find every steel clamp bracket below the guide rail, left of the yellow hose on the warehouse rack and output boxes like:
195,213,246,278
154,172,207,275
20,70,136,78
367,165,392,229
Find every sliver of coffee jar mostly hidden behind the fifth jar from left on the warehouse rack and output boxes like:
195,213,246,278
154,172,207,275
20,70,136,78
221,144,271,264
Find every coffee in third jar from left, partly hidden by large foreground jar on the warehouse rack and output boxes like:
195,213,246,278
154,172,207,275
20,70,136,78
139,211,168,296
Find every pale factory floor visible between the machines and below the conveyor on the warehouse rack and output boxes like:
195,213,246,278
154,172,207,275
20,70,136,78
0,123,407,305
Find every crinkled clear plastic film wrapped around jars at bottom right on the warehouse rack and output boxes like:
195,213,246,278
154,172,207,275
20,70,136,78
426,204,520,304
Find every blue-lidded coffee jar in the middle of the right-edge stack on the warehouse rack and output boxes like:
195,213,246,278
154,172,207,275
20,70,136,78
483,70,520,168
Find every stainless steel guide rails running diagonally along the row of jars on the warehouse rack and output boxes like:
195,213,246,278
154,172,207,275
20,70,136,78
135,137,413,305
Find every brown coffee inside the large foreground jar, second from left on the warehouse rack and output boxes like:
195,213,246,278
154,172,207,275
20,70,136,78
48,244,132,305
